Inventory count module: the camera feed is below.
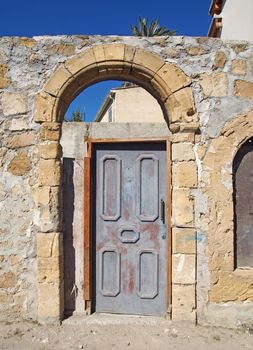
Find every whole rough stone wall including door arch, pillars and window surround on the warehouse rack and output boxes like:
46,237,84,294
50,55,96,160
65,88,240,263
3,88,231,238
0,36,253,326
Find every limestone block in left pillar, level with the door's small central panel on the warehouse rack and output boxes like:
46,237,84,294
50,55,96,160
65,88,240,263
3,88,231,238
37,232,63,258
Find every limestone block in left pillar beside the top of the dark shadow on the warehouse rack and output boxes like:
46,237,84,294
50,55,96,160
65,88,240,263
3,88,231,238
38,159,61,186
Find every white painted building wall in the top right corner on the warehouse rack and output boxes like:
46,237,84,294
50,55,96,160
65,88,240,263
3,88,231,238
221,0,253,41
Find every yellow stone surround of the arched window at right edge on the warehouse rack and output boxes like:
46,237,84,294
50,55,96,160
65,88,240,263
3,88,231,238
203,110,253,302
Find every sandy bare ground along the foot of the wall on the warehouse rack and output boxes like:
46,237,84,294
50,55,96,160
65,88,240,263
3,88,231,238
0,319,253,350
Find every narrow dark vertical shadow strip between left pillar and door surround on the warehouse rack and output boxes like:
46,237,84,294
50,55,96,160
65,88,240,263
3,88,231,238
63,158,77,316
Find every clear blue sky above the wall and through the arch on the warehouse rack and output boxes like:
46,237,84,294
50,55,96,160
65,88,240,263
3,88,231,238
0,0,211,119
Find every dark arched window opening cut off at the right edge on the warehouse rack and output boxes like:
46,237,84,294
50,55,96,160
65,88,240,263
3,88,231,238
233,137,253,267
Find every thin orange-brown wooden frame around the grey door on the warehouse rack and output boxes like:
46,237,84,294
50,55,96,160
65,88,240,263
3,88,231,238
83,136,172,316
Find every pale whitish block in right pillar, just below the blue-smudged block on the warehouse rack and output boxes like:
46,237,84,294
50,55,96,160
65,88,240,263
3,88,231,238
172,254,196,284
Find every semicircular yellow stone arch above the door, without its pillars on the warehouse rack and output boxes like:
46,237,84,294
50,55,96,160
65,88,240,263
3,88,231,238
35,44,197,124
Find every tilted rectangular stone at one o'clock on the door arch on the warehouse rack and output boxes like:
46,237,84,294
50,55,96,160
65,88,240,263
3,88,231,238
133,49,164,72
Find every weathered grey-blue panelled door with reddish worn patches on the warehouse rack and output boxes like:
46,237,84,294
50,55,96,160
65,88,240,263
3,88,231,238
93,143,167,315
